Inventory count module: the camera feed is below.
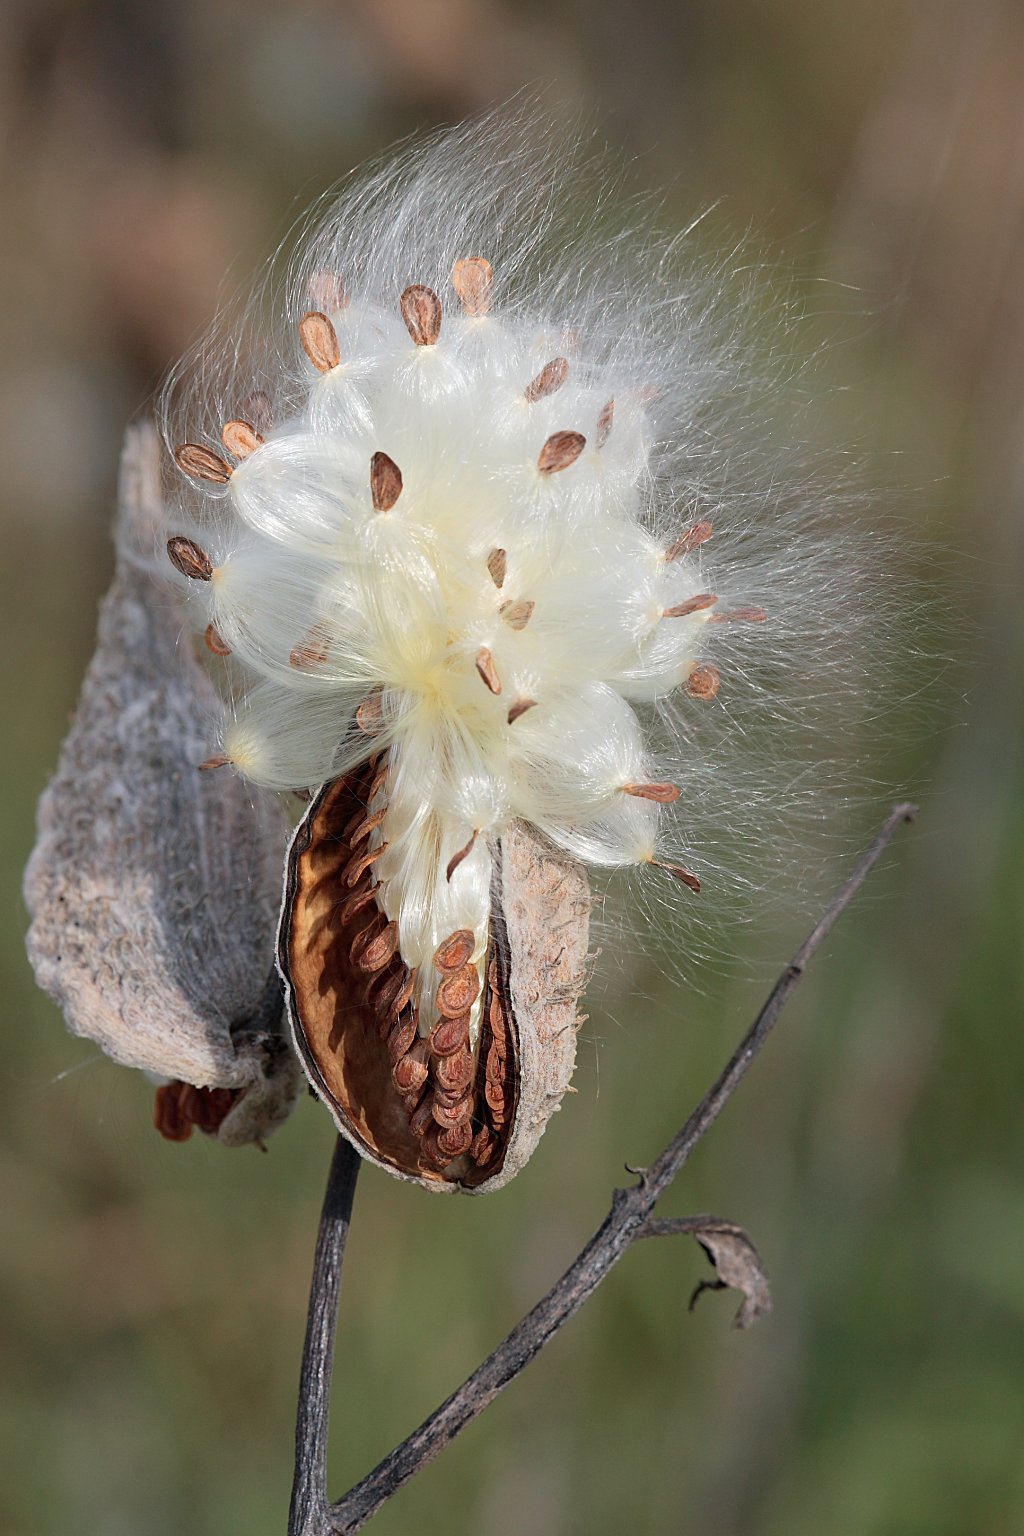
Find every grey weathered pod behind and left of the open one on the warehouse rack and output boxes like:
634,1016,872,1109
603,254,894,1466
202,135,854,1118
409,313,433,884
25,427,301,1143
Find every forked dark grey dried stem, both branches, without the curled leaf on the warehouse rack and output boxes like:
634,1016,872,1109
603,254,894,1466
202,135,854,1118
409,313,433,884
289,803,917,1536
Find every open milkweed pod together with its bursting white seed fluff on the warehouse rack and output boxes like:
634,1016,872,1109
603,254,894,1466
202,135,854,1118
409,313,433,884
164,117,890,1190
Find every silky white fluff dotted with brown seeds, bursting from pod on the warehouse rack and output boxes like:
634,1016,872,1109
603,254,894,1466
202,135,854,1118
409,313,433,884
161,111,884,995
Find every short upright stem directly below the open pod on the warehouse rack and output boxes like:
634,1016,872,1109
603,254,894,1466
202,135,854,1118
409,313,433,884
289,1137,361,1536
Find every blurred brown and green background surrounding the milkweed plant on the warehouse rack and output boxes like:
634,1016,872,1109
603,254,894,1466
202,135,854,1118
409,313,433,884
0,0,1024,1536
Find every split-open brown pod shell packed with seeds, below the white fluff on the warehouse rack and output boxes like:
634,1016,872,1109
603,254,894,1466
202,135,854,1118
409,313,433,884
278,757,590,1192
